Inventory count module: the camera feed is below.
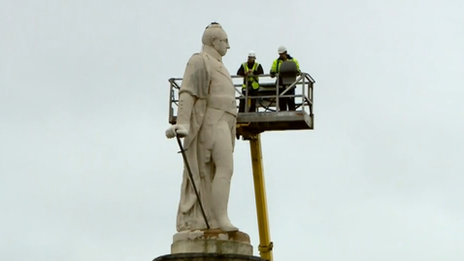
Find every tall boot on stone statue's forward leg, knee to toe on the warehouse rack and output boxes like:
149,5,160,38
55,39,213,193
212,177,238,232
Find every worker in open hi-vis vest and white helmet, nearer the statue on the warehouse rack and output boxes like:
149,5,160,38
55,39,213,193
237,51,264,112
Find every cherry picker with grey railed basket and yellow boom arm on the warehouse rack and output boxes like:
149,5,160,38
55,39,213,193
169,65,315,261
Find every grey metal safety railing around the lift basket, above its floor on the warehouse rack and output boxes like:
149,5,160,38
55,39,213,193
168,72,315,124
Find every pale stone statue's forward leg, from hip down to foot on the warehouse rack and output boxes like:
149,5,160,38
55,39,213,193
211,113,238,231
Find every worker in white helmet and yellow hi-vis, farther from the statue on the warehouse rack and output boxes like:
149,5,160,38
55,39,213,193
270,45,301,111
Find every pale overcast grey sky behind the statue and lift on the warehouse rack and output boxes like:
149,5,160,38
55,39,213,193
0,0,464,261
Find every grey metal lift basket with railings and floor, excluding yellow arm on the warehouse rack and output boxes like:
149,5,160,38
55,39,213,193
169,73,315,137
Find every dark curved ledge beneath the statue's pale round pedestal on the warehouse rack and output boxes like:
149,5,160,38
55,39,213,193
153,253,266,261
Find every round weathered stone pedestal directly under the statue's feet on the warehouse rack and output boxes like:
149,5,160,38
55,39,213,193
171,229,253,256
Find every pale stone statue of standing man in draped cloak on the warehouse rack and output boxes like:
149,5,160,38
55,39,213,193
166,23,238,232
